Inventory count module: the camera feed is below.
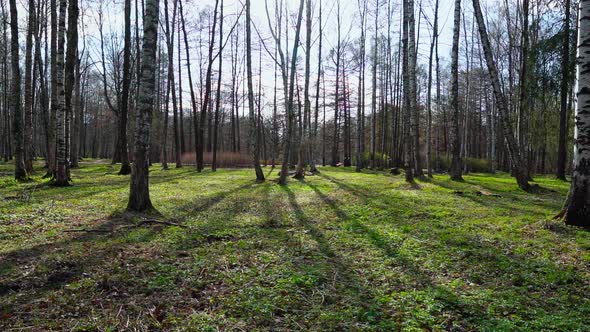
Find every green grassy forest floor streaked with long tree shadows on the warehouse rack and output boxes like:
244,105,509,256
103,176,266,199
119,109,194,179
0,162,590,331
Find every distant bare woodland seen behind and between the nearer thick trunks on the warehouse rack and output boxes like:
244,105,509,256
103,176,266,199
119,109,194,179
0,0,576,182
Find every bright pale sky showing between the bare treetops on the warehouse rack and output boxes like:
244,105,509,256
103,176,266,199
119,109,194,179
82,0,498,115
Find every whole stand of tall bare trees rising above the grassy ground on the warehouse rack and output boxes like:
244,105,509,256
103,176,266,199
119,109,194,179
0,0,590,225
